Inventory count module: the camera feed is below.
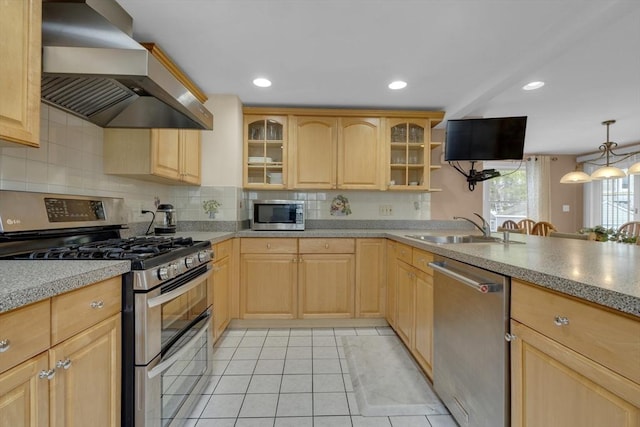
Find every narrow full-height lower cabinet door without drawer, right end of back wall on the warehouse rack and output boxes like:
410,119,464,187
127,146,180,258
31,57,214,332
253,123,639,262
356,239,386,317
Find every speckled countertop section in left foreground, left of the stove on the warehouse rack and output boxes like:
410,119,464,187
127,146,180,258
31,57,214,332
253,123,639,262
0,260,131,313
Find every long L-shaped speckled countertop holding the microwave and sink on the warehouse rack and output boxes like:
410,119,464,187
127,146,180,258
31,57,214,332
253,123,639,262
194,229,640,317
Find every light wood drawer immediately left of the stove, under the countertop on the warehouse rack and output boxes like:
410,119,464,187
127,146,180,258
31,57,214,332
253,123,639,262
51,276,122,345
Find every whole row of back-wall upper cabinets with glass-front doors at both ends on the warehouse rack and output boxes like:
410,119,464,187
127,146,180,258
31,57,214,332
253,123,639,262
244,107,444,191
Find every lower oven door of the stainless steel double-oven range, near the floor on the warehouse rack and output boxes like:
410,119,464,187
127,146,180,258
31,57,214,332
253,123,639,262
135,308,213,427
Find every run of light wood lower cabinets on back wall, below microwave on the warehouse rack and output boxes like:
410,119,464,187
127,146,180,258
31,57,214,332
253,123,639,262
240,238,386,319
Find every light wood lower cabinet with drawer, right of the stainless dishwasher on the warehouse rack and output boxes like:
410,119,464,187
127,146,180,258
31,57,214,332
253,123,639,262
511,280,640,427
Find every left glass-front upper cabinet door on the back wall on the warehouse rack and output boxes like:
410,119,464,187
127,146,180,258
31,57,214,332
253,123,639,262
244,116,287,189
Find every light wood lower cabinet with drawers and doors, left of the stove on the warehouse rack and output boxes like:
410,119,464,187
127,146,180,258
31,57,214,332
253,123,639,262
0,277,121,427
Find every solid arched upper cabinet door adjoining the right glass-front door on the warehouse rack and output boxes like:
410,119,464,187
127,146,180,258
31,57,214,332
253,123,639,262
338,117,382,190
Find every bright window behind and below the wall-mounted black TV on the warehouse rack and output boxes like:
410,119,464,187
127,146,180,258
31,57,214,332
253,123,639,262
483,161,528,231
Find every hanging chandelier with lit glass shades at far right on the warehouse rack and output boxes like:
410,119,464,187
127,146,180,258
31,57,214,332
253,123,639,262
560,120,640,184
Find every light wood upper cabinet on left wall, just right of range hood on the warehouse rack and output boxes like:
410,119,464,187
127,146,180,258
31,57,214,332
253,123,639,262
104,128,201,185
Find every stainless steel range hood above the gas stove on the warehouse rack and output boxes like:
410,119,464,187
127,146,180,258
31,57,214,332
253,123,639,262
42,0,213,129
